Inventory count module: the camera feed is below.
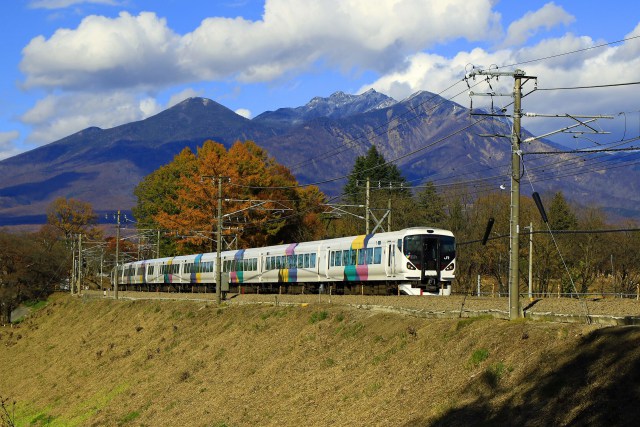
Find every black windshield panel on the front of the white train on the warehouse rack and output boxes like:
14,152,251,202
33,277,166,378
402,234,456,271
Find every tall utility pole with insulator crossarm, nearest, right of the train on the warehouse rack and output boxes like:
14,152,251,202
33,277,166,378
469,69,536,319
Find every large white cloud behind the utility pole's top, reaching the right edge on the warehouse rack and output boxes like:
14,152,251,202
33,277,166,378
360,32,640,142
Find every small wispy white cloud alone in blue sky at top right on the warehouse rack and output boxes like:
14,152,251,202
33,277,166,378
503,2,575,46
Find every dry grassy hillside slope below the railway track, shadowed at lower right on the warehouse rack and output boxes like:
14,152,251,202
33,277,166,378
0,295,640,426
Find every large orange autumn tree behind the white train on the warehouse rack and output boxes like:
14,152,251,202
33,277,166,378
143,141,326,253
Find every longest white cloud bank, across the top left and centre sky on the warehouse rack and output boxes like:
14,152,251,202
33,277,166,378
20,0,499,90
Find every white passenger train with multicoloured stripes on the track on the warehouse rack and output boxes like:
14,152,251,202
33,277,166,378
111,227,456,295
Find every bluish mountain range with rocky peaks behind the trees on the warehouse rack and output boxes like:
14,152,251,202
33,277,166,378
0,90,640,225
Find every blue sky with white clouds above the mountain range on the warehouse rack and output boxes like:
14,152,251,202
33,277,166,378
0,0,640,159
